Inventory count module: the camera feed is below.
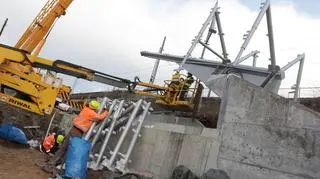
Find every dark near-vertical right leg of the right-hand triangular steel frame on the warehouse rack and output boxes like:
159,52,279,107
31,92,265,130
266,6,276,71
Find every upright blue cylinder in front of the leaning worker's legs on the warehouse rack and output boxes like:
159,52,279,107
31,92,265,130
64,137,91,179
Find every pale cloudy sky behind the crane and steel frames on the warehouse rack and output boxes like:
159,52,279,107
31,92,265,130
0,0,320,92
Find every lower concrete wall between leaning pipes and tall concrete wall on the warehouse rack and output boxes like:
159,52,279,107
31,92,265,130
129,122,219,179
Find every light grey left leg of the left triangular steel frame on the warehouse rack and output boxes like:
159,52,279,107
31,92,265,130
179,1,218,69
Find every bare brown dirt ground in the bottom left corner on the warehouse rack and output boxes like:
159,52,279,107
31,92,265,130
0,139,102,179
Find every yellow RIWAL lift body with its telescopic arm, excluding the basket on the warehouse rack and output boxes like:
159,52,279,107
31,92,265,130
0,44,131,115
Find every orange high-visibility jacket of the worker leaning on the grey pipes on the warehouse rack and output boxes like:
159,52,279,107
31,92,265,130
72,107,109,132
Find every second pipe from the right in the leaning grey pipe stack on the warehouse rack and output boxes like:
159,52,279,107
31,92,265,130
106,99,142,168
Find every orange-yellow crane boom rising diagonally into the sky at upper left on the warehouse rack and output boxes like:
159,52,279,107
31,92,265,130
15,0,73,54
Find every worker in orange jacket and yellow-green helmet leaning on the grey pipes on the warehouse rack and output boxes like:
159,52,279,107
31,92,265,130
42,100,109,172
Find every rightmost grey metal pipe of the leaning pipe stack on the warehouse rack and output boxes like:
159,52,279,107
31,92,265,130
123,102,151,165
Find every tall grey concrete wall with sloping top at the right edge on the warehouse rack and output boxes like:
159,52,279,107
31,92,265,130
218,76,320,179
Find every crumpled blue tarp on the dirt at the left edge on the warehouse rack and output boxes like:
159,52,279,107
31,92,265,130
0,124,28,144
